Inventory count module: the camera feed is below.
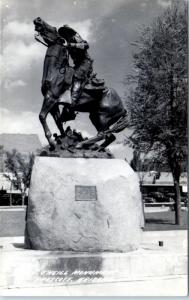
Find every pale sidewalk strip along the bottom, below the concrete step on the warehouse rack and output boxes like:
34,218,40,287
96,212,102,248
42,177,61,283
0,275,188,296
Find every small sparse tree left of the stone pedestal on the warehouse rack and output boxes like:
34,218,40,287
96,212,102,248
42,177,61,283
4,150,34,205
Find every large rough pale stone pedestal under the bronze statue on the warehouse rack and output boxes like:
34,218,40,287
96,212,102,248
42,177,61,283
25,157,143,252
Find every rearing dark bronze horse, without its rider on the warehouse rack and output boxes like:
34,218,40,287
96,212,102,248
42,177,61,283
34,17,128,150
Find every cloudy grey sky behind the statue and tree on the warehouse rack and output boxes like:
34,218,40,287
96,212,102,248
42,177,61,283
0,0,173,159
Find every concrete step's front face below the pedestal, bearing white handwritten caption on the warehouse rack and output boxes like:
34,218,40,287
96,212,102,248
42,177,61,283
0,245,187,288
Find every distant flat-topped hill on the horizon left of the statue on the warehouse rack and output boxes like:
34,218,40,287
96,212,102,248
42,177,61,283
0,133,42,154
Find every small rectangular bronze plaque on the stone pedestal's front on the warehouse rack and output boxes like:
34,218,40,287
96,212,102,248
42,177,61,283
75,185,97,201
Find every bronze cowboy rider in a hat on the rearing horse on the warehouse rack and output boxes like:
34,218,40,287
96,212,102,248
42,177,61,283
58,25,93,108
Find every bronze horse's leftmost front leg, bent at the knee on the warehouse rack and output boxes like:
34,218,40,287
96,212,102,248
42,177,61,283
39,93,55,150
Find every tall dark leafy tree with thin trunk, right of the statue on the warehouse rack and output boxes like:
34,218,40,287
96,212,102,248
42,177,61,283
127,1,187,224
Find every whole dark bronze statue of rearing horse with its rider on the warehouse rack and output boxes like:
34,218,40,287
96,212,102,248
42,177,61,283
34,17,128,151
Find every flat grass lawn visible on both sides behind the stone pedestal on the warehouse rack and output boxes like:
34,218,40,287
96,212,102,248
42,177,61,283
0,209,188,237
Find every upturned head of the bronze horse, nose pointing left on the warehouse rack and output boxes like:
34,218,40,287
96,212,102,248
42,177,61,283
33,17,59,46
